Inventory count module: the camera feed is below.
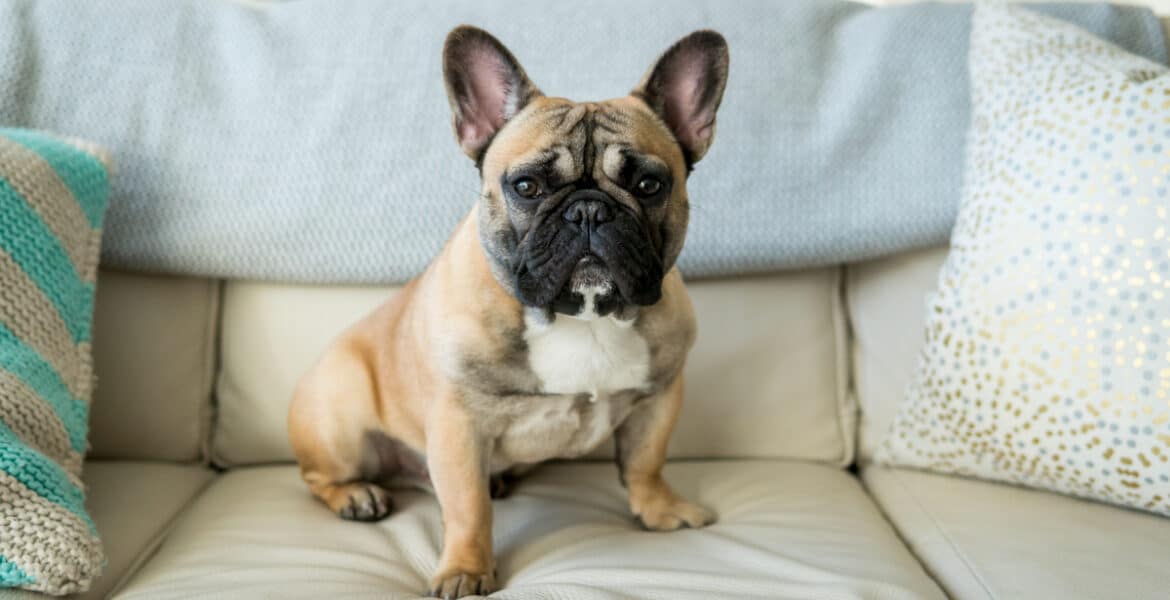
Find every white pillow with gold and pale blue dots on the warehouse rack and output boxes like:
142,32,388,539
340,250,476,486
879,5,1170,515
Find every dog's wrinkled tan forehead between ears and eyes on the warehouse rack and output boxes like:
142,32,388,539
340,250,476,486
482,97,686,181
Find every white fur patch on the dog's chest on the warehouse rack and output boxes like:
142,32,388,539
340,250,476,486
524,306,651,399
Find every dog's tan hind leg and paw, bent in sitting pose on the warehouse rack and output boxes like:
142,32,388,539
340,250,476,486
289,352,393,520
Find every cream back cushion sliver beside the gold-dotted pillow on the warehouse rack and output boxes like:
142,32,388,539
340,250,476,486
845,248,947,460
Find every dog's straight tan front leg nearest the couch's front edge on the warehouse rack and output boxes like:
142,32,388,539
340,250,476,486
426,394,496,598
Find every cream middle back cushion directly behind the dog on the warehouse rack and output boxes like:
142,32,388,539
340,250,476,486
213,269,854,465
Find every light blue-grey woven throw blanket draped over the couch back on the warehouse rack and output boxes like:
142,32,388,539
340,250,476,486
0,0,1165,283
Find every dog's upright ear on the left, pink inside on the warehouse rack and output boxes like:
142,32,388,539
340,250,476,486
442,25,541,160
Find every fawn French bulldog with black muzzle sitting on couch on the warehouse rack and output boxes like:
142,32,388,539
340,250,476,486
289,26,729,598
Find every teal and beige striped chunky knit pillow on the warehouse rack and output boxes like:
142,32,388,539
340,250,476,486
0,129,109,594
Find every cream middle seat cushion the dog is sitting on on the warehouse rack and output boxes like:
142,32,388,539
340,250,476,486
117,461,943,600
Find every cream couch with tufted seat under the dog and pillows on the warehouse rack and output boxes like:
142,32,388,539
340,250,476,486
0,7,1170,600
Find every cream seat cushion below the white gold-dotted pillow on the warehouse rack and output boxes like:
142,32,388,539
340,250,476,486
863,467,1170,599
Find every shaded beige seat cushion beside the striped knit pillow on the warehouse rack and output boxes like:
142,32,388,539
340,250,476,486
0,461,213,600
